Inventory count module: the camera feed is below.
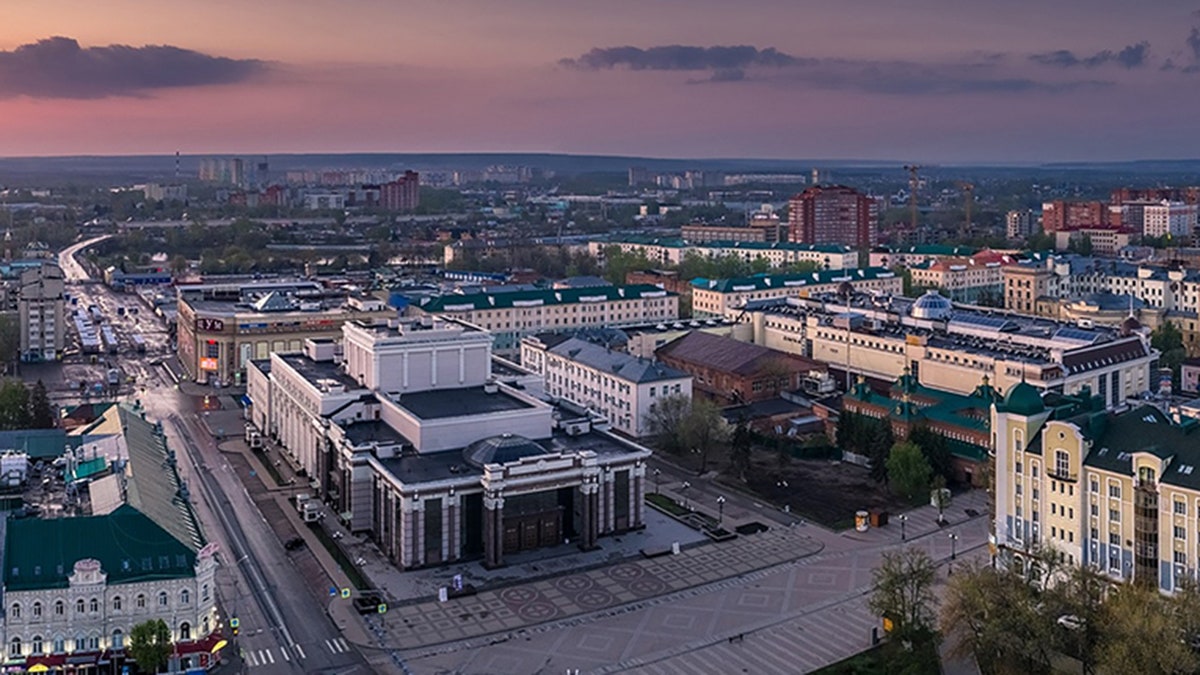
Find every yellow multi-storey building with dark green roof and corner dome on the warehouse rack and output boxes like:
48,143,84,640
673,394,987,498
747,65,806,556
991,383,1200,592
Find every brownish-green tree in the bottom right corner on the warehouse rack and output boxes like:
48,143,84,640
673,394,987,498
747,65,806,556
1096,584,1200,675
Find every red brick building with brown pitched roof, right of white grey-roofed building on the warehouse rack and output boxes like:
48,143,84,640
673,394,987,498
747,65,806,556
654,330,826,405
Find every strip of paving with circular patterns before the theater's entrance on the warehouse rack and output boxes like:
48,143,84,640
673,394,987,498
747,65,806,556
388,527,822,649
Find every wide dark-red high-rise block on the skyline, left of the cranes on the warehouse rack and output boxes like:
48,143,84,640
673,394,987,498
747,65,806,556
788,185,877,247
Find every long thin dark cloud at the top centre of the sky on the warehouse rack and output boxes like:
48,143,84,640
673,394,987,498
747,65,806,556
559,44,803,72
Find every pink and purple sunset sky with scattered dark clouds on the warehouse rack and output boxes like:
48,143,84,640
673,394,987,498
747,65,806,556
0,0,1200,163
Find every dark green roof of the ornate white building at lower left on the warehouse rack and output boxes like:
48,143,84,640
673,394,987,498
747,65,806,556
4,506,196,591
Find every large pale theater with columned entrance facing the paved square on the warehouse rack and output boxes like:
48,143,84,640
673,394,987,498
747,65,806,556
247,316,650,569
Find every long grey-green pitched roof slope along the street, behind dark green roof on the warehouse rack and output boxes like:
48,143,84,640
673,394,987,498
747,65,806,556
121,406,204,551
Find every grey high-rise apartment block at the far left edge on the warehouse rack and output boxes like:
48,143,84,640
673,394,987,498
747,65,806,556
17,263,66,362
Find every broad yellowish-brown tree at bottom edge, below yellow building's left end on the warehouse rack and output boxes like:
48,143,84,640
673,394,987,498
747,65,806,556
941,563,1054,675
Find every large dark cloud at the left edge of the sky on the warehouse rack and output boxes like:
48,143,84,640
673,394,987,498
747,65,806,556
0,37,266,98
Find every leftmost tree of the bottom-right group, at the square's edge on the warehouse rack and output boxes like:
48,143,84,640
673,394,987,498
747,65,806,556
868,546,937,643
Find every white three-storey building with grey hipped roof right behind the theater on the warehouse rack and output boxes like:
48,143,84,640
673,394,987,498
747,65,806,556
521,334,691,437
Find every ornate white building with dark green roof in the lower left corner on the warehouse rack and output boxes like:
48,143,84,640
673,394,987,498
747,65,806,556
2,407,221,673
